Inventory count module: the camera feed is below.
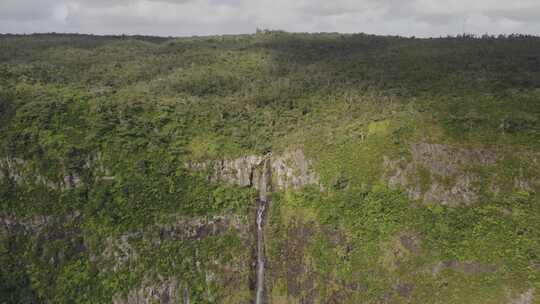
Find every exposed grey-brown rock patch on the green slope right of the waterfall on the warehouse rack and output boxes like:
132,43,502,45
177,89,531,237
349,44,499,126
384,143,531,207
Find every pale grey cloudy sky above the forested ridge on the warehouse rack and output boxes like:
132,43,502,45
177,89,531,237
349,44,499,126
0,0,540,37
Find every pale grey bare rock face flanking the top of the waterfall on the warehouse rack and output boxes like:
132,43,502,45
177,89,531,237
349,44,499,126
186,150,320,190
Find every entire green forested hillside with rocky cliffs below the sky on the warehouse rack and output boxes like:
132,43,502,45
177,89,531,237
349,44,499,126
0,32,540,304
